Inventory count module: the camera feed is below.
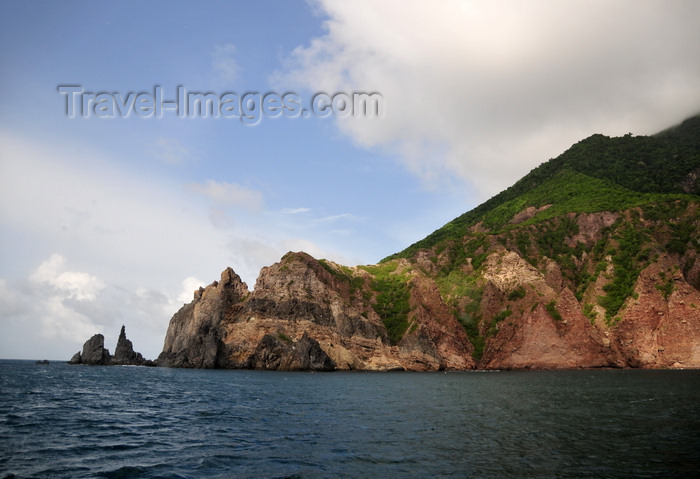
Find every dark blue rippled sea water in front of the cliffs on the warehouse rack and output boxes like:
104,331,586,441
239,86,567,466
0,361,700,478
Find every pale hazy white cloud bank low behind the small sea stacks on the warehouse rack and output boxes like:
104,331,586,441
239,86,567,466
0,130,370,359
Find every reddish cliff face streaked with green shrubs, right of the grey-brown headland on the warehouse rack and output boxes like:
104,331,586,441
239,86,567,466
432,208,700,369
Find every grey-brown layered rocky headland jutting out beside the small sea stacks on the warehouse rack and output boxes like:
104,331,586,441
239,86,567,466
158,253,474,370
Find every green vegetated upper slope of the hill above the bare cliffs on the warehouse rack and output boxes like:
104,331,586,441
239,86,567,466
382,115,700,261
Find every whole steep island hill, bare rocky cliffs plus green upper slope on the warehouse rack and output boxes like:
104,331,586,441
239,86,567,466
159,117,700,370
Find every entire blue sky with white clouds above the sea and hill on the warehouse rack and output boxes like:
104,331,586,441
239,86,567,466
0,0,700,360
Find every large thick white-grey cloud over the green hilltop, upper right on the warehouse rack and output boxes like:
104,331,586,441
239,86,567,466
274,0,700,199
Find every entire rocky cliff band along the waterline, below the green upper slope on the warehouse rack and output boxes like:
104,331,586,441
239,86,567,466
158,203,700,371
